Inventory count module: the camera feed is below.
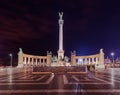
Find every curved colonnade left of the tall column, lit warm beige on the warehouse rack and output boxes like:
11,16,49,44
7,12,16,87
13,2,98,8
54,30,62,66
18,50,52,67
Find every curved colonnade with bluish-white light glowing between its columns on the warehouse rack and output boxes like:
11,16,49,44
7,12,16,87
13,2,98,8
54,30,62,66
71,49,104,68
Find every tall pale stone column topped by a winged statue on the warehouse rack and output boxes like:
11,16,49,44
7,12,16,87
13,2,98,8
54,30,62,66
58,12,64,59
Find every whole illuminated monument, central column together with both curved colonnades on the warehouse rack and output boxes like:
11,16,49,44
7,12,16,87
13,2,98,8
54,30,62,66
18,12,105,70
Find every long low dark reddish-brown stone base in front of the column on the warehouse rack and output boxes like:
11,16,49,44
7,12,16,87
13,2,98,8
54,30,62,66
33,66,87,74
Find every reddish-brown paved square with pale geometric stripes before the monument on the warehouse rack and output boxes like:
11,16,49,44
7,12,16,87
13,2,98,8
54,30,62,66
0,68,120,95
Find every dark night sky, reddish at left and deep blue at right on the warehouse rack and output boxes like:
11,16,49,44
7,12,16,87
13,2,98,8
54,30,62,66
0,0,120,64
